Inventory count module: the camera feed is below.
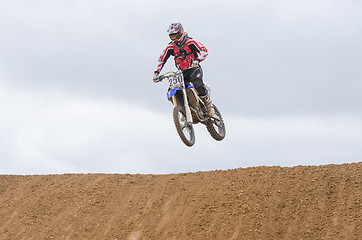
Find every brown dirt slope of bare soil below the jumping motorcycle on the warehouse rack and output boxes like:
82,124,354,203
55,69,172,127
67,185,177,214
0,163,362,240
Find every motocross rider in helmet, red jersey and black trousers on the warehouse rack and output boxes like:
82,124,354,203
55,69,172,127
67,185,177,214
153,23,215,117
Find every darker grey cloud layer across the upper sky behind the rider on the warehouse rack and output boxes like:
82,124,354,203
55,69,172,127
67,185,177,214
0,1,362,116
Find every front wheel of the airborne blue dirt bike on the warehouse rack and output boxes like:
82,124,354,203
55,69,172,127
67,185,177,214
173,106,195,147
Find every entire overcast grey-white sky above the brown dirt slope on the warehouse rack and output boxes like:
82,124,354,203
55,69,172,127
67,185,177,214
0,0,362,174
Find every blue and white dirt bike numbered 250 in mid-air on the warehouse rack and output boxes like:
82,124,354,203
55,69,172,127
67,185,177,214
158,70,226,147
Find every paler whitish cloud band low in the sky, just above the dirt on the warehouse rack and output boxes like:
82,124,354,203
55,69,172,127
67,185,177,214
0,82,362,174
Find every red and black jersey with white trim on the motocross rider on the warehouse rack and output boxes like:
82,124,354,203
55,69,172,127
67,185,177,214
155,37,208,73
